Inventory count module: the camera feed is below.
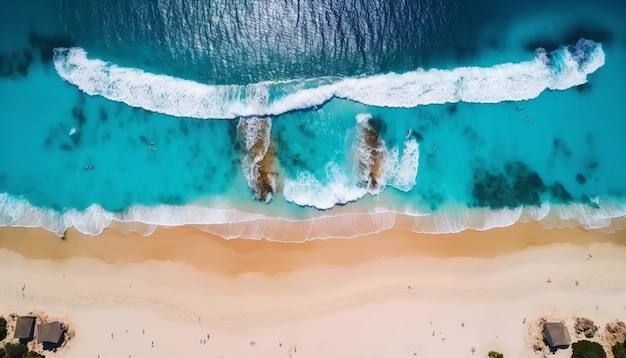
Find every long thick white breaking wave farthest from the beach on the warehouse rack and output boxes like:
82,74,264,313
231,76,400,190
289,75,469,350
54,39,604,119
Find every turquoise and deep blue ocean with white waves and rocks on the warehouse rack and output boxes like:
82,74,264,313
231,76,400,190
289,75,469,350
0,0,626,241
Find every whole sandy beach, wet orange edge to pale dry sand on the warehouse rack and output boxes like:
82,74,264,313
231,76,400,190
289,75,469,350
0,223,626,358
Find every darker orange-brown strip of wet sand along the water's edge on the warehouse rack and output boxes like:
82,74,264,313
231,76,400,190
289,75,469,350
0,222,626,274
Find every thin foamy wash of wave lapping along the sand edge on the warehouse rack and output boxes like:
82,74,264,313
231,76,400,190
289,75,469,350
0,193,626,242
